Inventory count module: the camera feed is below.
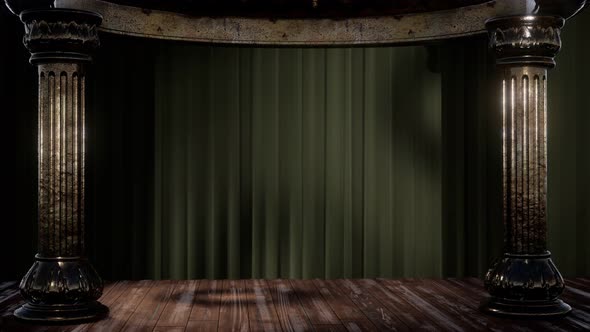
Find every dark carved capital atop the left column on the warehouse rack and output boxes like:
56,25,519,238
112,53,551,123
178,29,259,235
20,9,102,63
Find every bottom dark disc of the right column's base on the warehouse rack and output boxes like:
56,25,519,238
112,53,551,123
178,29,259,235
480,297,572,318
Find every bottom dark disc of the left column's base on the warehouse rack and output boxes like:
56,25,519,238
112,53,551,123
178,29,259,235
14,301,109,323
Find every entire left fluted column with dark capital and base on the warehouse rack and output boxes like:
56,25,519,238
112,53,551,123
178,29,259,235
14,9,108,322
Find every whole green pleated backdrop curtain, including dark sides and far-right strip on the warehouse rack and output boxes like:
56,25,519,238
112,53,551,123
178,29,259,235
78,8,590,279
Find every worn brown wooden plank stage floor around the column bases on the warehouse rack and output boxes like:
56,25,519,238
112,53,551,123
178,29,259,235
0,278,590,332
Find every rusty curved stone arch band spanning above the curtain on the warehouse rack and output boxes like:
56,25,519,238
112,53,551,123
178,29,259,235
56,0,520,46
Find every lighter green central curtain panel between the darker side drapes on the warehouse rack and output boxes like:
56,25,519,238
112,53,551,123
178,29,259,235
153,44,442,278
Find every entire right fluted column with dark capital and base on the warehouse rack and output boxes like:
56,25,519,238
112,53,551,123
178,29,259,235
482,16,571,316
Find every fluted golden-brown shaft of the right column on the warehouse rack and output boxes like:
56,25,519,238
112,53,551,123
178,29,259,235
502,66,547,254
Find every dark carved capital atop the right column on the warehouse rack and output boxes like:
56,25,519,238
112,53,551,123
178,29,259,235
486,15,565,68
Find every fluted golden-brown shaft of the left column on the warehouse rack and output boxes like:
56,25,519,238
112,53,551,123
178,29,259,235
38,63,86,257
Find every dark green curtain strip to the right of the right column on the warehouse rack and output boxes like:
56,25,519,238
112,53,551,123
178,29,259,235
547,10,590,276
